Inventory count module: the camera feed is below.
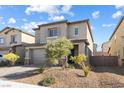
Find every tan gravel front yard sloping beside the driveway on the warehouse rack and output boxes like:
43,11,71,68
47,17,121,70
11,67,124,88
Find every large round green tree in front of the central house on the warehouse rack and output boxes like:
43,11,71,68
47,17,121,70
47,37,73,66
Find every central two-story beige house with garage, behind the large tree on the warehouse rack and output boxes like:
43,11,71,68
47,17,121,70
25,20,93,64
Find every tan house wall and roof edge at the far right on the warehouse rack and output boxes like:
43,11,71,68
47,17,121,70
104,17,124,66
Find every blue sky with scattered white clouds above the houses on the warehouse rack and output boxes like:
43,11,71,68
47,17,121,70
0,5,124,47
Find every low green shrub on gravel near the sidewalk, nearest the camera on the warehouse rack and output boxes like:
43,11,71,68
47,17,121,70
39,77,55,86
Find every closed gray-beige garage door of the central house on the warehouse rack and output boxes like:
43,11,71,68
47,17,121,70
32,49,46,64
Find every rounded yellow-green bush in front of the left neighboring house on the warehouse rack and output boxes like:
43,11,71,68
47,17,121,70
3,53,20,65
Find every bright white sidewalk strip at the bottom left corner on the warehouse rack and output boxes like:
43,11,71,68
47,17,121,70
0,80,45,88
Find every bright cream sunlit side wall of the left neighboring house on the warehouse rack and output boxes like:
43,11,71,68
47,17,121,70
21,33,35,43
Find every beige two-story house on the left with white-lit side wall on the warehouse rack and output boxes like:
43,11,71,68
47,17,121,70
0,27,35,62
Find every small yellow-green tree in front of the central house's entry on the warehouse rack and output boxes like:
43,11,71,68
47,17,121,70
71,54,90,77
